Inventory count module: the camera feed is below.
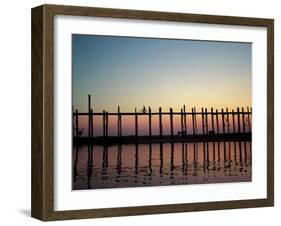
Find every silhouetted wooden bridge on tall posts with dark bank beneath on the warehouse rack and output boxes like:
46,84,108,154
73,95,252,143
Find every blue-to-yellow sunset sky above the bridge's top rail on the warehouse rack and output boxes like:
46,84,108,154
72,34,252,135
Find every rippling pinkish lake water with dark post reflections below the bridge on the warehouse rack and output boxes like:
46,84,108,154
72,141,252,190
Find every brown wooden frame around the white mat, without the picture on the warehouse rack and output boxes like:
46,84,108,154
31,5,274,221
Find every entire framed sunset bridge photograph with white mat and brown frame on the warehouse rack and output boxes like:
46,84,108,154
32,5,274,221
